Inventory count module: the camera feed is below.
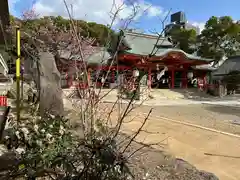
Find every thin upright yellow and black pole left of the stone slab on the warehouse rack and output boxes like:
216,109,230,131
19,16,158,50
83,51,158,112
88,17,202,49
16,28,21,123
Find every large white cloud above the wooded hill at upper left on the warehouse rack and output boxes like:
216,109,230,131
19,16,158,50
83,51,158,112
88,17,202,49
34,0,164,24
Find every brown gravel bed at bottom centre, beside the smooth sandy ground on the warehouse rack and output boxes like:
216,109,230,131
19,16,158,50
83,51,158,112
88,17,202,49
119,134,218,180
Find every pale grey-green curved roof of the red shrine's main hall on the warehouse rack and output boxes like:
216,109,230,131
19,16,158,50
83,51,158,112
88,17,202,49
121,32,213,62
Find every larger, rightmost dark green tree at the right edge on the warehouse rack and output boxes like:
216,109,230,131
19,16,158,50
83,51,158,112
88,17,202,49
198,16,240,61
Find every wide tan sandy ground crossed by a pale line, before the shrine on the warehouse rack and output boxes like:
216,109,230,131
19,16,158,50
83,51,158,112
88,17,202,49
100,104,240,180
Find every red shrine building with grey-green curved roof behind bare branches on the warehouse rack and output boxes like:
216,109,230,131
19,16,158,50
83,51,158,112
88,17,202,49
57,31,213,89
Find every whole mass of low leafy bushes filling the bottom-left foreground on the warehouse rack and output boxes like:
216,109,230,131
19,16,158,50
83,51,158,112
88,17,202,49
1,105,131,180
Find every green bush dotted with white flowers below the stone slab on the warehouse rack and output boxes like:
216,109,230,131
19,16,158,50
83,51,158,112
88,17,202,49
6,113,74,177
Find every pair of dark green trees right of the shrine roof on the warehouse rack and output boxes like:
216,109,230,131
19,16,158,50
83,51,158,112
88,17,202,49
166,16,240,61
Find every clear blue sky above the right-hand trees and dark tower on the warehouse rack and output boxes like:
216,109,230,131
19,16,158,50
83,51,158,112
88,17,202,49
138,0,240,30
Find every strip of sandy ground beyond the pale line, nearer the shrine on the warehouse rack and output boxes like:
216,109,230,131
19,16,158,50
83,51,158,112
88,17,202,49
133,104,240,134
